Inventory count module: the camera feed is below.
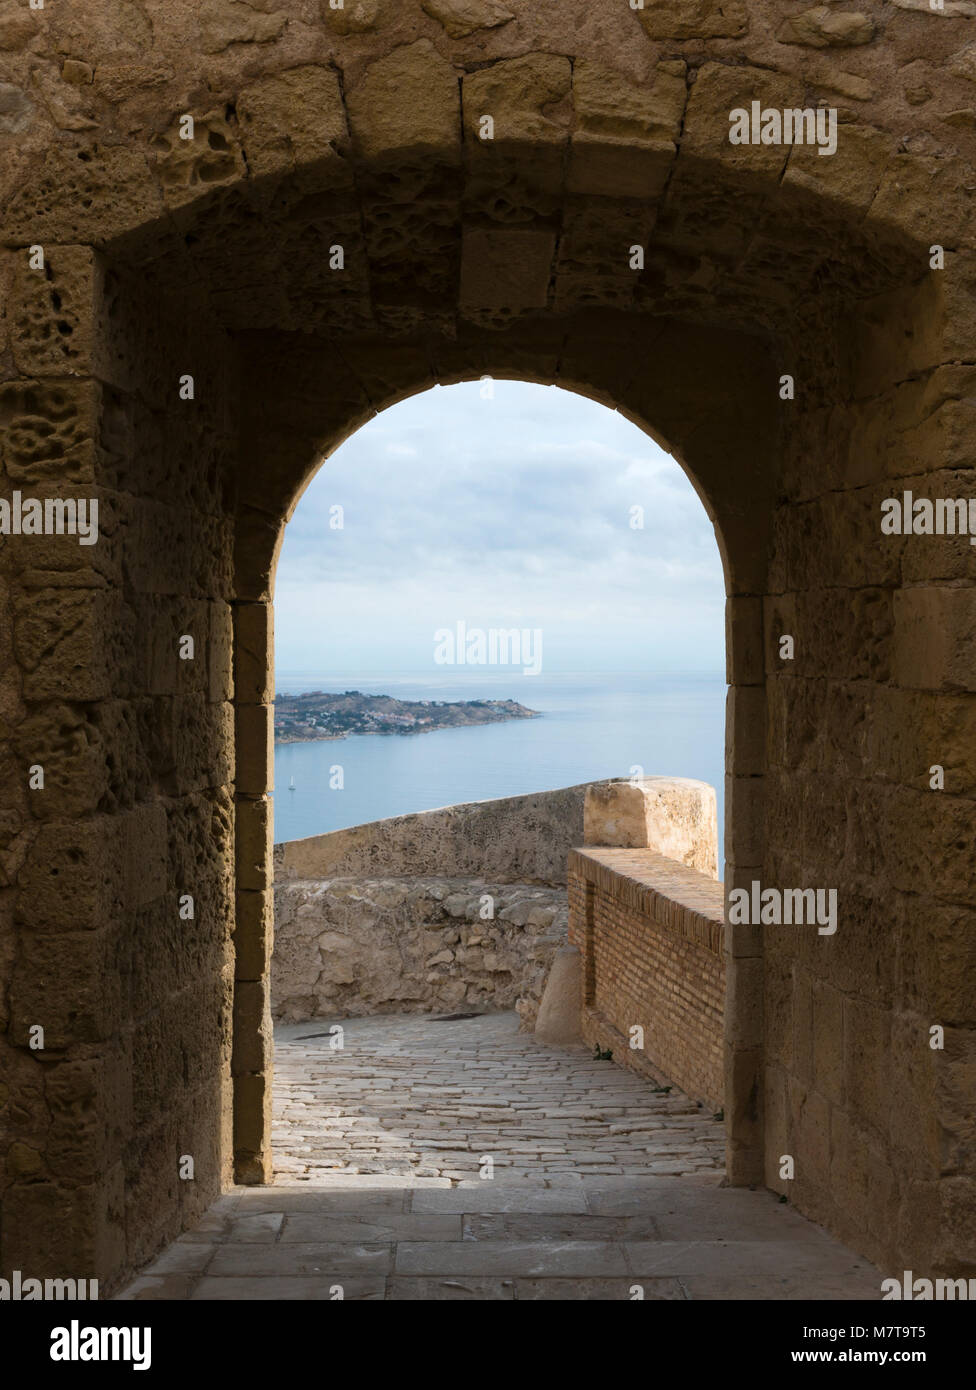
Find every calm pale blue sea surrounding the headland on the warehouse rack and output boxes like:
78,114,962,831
274,669,726,858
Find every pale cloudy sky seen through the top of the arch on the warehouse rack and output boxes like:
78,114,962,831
275,381,724,676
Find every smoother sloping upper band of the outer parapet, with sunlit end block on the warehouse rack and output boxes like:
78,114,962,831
274,777,717,884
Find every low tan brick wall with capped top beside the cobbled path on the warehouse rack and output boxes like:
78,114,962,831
569,848,726,1108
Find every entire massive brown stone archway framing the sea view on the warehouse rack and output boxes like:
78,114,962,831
0,8,973,1279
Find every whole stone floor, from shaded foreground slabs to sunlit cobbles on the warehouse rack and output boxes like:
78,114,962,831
118,1015,880,1300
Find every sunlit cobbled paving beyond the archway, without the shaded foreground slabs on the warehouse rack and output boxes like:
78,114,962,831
274,1013,726,1182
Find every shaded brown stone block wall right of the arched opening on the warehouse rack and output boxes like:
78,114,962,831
761,284,976,1273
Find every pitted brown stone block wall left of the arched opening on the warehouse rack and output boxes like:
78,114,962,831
0,252,240,1277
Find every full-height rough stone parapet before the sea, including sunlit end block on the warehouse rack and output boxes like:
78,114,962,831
271,777,717,1027
